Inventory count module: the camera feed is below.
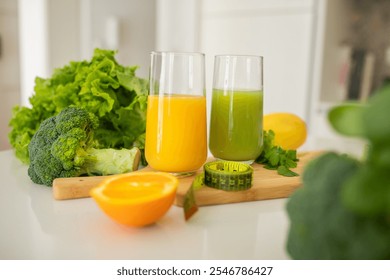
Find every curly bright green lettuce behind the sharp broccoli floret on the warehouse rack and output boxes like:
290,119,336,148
8,49,148,163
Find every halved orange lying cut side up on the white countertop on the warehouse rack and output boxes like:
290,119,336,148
90,172,179,227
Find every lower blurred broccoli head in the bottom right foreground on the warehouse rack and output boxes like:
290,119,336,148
287,153,390,259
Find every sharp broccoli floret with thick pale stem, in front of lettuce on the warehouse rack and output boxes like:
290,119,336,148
28,107,140,186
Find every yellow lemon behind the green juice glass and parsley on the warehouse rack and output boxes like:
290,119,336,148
263,113,307,150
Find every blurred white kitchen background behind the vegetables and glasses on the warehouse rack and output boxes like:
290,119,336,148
0,0,390,153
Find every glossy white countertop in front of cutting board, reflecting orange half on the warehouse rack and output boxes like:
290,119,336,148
0,151,288,260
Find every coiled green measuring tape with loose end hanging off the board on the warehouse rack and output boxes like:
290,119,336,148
183,160,253,220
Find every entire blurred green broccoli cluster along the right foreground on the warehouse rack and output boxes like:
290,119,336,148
287,80,390,259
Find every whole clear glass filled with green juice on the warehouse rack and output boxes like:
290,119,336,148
209,55,263,164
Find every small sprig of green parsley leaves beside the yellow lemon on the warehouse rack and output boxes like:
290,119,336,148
256,130,298,177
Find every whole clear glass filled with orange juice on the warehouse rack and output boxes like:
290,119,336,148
145,52,207,176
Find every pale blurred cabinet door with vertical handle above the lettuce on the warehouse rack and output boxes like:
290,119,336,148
80,0,156,78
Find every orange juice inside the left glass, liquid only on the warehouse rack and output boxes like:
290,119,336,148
145,94,207,173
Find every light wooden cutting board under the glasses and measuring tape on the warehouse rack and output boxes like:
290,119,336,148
53,152,320,206
